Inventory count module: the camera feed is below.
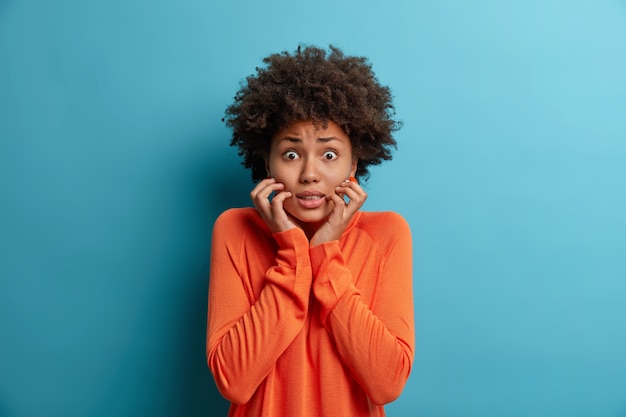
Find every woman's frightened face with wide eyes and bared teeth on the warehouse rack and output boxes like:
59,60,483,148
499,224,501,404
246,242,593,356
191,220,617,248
266,121,357,228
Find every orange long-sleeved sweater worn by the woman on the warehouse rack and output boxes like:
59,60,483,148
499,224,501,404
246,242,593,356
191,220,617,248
206,208,414,417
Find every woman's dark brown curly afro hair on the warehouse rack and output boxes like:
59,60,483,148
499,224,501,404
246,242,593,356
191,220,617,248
222,45,401,182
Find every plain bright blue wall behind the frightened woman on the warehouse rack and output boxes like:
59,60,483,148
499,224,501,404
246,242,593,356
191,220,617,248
0,0,626,417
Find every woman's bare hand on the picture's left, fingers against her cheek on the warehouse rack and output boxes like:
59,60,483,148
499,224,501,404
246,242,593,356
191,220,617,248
250,178,296,233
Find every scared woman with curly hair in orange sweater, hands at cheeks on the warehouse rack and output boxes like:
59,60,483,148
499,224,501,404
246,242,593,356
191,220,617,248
206,47,414,417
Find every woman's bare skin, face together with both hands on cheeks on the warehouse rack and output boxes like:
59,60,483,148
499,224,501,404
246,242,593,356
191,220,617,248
250,121,367,246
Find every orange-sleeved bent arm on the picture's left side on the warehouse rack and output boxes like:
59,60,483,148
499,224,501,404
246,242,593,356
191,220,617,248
206,211,311,403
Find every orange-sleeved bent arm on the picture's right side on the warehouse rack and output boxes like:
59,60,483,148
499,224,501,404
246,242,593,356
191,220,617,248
310,211,414,404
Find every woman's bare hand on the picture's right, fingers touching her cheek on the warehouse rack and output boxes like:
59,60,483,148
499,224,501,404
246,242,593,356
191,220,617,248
311,180,367,246
